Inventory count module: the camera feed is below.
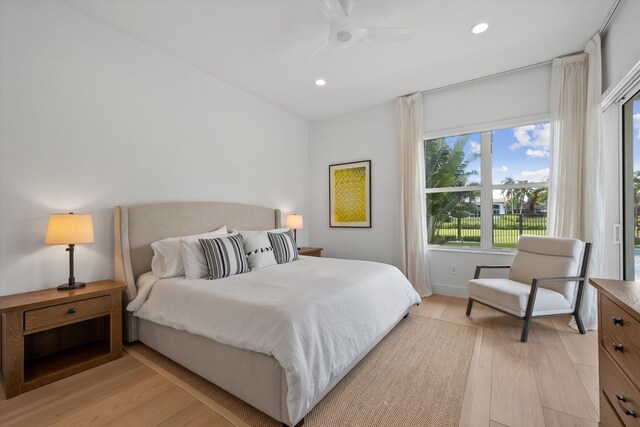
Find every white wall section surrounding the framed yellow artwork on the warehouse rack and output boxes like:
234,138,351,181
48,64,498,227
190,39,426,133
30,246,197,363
307,102,400,266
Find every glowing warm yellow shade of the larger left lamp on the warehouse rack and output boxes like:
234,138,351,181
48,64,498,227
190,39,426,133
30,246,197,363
44,213,94,245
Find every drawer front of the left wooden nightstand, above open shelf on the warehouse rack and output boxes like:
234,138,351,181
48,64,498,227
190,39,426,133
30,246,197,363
24,295,111,332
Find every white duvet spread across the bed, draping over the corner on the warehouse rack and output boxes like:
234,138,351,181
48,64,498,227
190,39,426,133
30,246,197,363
127,257,420,420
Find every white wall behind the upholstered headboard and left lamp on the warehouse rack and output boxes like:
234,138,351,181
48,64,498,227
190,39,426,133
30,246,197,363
0,1,308,294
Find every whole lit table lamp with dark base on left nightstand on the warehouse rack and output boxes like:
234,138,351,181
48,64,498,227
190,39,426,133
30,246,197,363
44,212,94,290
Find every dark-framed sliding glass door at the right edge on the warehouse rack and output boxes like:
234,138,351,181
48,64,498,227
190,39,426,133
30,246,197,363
622,91,640,280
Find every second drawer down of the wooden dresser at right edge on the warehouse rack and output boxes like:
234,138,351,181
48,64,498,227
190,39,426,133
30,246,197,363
599,348,640,427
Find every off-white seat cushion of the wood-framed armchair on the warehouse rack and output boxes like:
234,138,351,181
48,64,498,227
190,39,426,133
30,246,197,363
469,279,573,317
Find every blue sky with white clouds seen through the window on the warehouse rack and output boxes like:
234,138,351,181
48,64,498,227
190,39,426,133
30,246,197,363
446,123,552,184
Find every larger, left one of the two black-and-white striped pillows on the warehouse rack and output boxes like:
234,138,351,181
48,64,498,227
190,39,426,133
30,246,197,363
199,234,249,280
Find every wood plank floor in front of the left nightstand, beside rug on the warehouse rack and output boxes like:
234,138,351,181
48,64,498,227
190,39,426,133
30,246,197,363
0,352,233,427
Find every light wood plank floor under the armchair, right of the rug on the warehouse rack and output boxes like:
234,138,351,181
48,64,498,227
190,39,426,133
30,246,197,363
412,295,598,427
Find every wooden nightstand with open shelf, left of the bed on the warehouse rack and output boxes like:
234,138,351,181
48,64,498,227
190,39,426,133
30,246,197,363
0,280,124,398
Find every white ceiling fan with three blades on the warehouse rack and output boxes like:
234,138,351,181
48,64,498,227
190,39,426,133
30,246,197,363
307,0,418,62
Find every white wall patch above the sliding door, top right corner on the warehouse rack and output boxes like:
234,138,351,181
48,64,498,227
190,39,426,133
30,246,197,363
602,0,640,92
